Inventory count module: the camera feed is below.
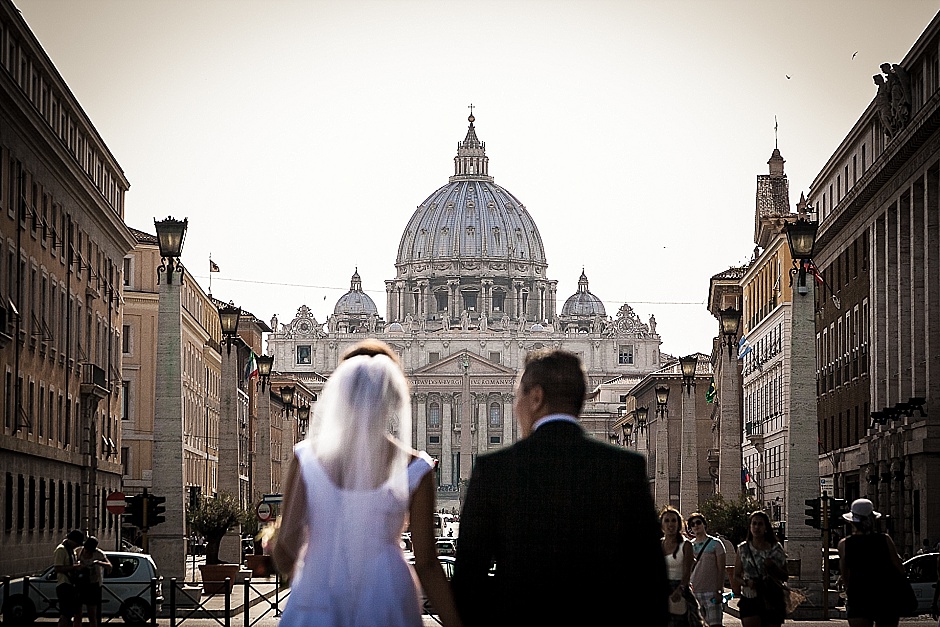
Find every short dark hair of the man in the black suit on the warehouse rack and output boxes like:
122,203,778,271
519,348,587,416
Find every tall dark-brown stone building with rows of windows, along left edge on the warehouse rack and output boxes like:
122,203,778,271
0,0,134,575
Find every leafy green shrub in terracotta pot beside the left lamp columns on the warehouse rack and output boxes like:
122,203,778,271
186,492,248,594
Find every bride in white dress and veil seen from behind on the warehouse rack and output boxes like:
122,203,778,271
272,340,460,627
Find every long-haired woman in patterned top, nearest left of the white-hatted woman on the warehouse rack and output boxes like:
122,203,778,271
734,510,787,627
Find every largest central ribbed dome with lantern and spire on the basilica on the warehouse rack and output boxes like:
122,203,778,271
396,115,547,276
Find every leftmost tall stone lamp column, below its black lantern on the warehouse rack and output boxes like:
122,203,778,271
148,271,187,581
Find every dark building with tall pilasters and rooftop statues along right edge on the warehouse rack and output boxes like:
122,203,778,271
808,15,940,554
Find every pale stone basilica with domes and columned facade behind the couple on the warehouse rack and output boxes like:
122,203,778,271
267,115,664,489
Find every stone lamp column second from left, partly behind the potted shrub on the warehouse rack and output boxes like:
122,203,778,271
218,346,242,564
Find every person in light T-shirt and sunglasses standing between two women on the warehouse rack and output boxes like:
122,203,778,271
689,512,726,627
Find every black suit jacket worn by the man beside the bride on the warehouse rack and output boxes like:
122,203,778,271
452,421,668,626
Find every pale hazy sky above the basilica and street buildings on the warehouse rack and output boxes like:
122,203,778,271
13,0,940,355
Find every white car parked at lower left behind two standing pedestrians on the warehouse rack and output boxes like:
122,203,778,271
0,551,163,625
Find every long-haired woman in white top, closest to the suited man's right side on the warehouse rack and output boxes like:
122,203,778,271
659,505,704,627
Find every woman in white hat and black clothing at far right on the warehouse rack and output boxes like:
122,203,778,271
839,499,910,627
